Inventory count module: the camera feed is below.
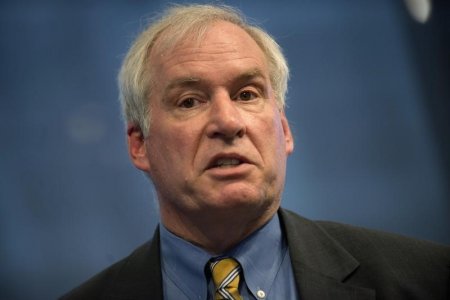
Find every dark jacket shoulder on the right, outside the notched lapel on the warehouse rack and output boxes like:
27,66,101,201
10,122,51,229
317,221,450,299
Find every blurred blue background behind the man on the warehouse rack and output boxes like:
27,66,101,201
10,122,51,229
0,0,450,299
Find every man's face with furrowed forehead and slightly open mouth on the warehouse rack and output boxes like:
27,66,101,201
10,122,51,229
129,22,293,226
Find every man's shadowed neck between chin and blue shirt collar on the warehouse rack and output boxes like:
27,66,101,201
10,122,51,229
161,206,278,255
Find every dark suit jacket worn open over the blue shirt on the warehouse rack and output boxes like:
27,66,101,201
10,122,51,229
62,209,450,300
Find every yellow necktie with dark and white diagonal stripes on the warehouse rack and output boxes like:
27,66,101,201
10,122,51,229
209,257,242,300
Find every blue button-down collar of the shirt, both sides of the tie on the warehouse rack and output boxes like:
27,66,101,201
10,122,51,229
160,214,287,299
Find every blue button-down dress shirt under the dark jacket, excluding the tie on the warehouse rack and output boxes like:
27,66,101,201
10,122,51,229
160,214,299,300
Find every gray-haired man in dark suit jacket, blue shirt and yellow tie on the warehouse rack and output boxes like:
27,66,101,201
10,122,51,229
64,5,450,300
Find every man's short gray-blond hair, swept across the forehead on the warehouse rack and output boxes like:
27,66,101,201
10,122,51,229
118,5,289,137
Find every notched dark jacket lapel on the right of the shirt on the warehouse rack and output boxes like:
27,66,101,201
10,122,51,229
279,209,375,300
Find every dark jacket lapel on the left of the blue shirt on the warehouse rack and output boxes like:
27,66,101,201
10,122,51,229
104,226,163,300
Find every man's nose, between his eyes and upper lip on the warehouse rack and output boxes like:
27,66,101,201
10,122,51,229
206,93,246,140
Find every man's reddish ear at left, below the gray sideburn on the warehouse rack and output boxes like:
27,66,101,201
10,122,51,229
127,124,150,173
